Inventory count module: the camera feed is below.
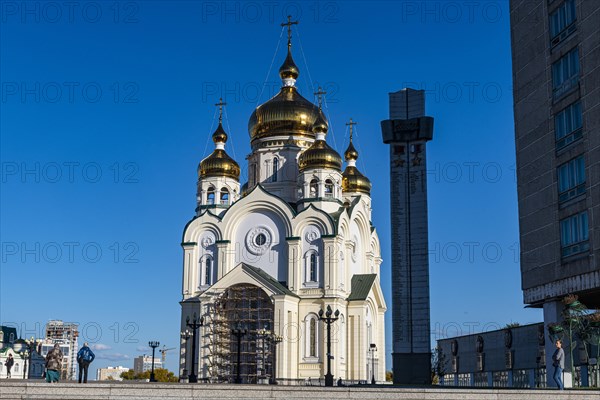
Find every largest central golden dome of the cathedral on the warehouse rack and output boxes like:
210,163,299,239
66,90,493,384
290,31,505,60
248,86,325,141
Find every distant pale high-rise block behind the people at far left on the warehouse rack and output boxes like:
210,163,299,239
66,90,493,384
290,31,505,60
41,320,79,380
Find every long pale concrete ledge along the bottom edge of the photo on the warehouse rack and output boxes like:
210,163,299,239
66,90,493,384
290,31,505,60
0,381,599,400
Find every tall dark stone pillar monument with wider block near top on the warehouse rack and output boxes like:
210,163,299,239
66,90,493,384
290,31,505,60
381,89,433,384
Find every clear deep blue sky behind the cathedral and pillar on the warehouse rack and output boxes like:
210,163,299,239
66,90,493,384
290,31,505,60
0,1,541,378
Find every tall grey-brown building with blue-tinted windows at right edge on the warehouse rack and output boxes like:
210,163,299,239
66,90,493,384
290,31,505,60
510,0,600,384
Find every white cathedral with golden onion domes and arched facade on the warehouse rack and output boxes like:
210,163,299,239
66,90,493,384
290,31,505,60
179,22,386,384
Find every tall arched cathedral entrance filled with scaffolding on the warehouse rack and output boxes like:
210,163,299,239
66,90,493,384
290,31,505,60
204,284,275,383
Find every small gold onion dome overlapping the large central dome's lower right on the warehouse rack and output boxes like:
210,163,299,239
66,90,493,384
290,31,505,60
298,115,342,171
